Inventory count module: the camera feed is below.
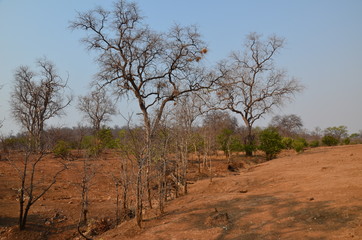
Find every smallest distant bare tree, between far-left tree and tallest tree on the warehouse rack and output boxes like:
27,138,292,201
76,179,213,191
78,88,117,132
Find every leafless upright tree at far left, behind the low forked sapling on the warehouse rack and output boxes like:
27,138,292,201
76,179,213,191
10,58,71,150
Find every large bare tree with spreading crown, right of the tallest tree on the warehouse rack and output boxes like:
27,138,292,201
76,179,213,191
217,33,303,156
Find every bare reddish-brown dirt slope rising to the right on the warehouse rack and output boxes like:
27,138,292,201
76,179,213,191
98,145,362,240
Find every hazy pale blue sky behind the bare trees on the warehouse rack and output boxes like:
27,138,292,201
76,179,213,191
0,0,362,135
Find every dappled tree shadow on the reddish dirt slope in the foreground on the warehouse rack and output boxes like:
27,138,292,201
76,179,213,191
163,195,362,240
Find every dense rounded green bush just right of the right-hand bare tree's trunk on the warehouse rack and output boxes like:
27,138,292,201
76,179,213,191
259,128,283,160
